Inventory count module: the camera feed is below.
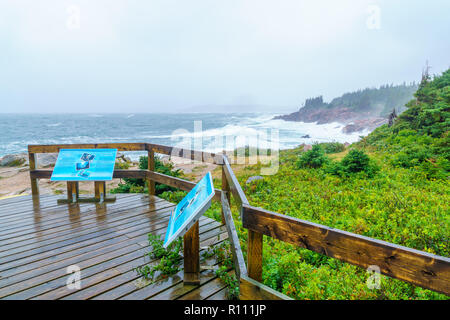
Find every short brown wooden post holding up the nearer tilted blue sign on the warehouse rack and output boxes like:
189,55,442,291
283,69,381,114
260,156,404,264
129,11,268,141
183,221,200,285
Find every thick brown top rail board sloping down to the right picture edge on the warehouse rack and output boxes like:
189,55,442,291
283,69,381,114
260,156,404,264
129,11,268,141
242,205,450,295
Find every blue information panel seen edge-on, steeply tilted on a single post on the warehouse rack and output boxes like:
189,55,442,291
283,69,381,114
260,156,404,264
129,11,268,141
164,172,214,248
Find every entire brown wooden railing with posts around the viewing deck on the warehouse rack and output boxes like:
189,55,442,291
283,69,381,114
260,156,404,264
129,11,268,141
28,143,450,299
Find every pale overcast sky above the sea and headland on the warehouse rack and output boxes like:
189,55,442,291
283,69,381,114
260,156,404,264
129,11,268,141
0,0,450,113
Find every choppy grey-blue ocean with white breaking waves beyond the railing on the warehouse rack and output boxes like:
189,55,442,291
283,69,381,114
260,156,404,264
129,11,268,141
0,113,368,156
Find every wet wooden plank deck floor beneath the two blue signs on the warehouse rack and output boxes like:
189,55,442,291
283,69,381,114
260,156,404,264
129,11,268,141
0,194,227,300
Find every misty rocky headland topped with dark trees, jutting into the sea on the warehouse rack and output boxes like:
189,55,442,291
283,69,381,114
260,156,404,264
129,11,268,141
274,83,417,133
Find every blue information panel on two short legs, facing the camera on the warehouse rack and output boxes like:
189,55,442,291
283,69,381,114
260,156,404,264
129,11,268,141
50,149,117,181
